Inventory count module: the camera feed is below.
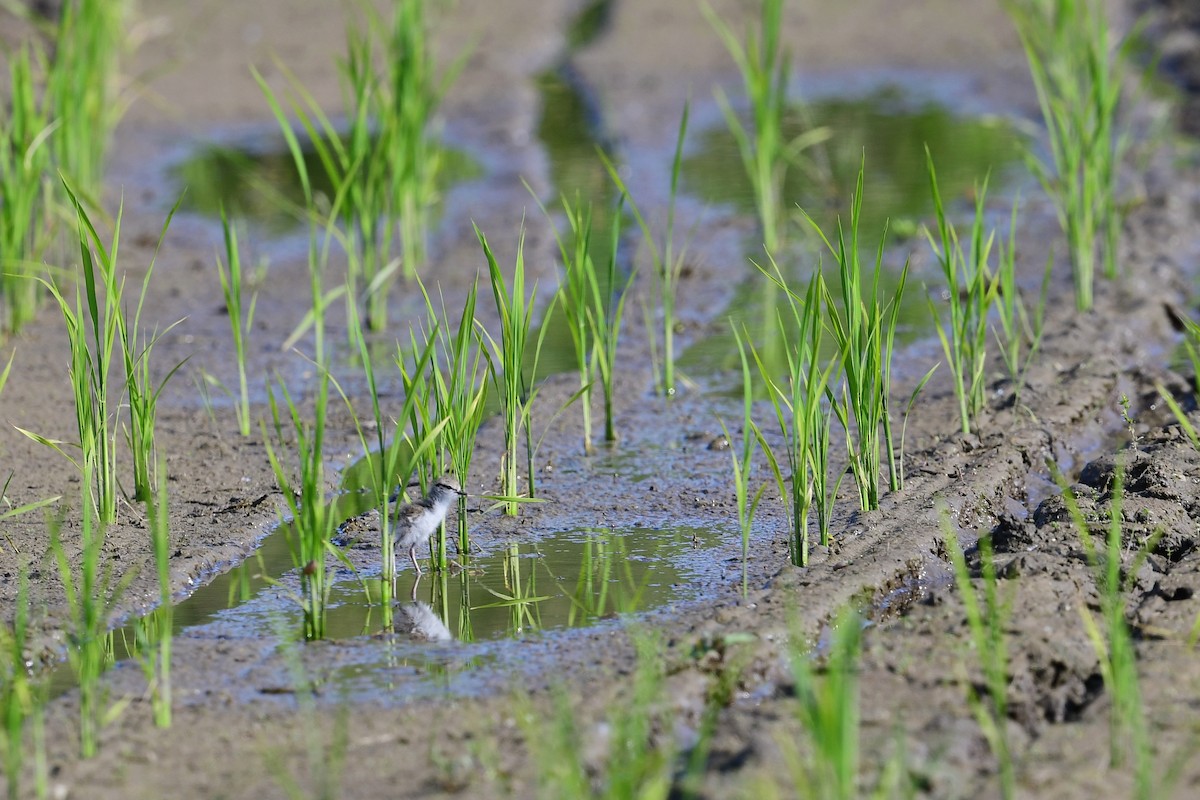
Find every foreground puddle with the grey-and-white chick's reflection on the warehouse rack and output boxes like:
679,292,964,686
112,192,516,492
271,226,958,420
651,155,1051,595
50,527,728,694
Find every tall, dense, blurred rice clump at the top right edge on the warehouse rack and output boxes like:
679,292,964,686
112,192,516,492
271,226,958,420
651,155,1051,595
1004,0,1134,311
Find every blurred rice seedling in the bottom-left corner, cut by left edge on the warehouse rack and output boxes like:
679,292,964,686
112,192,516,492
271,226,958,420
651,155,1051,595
0,566,47,800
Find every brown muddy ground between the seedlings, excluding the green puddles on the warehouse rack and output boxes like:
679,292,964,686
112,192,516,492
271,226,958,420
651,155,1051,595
0,0,1200,799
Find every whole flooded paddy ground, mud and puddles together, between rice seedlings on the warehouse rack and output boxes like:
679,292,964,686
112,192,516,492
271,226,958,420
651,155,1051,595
0,0,1200,799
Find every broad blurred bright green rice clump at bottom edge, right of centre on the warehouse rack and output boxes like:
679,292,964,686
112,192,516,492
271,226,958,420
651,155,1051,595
784,609,863,800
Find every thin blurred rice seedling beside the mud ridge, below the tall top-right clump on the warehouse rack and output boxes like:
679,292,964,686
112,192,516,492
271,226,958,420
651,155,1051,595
992,197,1054,404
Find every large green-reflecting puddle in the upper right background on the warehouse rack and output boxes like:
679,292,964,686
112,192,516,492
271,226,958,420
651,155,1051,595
678,88,1021,386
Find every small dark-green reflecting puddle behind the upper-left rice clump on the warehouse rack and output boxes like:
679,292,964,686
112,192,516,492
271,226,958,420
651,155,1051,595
170,132,484,234
